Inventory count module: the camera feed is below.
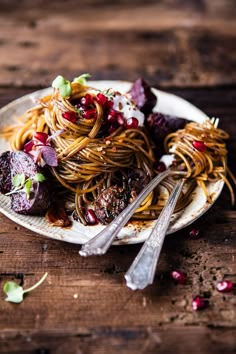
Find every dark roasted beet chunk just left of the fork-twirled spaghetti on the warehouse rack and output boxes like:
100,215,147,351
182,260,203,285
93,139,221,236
146,112,188,142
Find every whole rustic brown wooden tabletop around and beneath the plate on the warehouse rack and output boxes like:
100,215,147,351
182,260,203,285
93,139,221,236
0,0,236,354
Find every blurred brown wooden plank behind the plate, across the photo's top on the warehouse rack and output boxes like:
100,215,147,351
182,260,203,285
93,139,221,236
0,0,236,87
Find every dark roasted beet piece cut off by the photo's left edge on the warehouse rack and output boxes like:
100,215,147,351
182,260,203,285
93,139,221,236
0,151,11,194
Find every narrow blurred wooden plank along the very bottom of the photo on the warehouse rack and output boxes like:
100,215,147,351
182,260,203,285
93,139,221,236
0,326,236,354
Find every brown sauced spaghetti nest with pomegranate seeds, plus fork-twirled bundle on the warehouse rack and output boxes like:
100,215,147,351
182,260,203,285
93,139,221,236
2,77,234,224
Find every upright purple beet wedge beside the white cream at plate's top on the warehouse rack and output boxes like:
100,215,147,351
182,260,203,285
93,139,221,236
129,79,157,116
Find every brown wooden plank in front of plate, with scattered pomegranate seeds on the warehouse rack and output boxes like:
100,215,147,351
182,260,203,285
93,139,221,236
0,194,236,331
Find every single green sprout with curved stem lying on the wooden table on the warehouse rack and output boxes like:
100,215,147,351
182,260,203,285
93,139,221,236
3,272,48,304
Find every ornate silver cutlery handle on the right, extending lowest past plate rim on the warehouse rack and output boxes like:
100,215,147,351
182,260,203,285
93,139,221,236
125,178,185,290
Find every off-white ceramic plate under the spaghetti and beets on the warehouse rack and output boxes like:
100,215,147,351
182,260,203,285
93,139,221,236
0,81,224,244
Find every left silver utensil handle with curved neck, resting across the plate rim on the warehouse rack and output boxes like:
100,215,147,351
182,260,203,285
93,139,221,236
79,170,186,257
